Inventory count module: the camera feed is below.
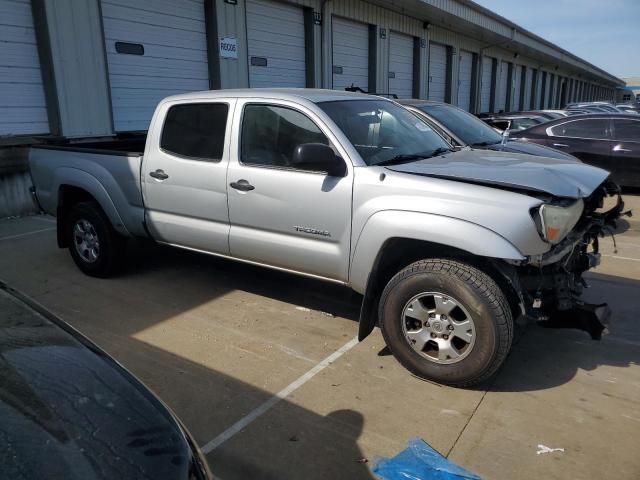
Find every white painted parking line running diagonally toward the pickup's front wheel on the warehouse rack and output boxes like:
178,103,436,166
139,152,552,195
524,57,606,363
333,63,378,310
201,338,358,453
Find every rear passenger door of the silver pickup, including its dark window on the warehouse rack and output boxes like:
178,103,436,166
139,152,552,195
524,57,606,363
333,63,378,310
141,100,235,254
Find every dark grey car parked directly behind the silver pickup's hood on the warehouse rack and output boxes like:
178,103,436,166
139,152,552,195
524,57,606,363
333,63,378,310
398,100,576,160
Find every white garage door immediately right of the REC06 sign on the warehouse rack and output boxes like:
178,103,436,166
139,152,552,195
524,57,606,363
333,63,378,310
246,0,306,88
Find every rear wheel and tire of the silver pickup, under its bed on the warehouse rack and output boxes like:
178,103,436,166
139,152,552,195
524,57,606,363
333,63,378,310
64,202,126,278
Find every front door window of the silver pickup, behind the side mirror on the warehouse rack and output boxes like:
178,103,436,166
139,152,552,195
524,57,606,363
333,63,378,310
240,105,329,167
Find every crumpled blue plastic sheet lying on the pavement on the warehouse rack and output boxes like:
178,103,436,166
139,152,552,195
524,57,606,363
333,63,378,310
373,438,480,480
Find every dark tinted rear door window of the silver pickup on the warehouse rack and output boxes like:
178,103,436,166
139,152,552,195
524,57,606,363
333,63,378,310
160,103,229,162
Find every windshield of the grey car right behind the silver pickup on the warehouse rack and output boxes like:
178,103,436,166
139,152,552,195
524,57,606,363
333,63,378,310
418,105,502,145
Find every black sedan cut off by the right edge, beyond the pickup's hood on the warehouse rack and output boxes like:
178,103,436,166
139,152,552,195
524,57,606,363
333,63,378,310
513,113,640,187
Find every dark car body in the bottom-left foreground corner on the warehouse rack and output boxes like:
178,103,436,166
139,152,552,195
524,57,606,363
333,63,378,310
0,282,211,480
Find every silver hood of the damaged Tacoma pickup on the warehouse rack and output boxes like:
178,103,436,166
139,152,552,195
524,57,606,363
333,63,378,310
387,149,609,198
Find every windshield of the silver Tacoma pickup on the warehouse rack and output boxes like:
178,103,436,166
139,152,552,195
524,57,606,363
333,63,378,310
318,99,451,166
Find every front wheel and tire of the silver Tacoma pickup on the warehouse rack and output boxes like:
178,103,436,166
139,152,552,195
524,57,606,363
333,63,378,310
379,259,513,387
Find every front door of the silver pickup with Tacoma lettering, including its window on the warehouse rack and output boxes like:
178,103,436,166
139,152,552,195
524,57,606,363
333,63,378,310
228,103,353,281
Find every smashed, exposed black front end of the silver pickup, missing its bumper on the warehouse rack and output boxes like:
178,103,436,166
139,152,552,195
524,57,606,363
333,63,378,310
514,181,631,340
